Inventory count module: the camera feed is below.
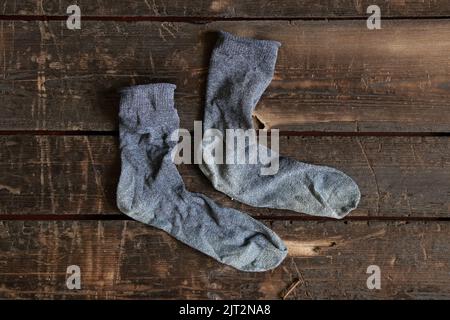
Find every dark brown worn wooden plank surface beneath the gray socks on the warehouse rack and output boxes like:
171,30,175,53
0,0,450,299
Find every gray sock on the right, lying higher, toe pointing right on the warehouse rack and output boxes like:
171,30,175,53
200,32,360,218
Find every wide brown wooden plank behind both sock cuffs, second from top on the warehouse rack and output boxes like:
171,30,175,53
0,20,450,132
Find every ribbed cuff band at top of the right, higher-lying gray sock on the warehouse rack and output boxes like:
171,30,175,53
215,31,281,60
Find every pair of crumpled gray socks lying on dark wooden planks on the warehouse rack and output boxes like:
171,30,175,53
117,32,360,271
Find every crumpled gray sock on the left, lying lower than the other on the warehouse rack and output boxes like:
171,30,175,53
117,83,287,271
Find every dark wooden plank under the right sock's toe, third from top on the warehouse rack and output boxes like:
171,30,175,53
0,135,450,218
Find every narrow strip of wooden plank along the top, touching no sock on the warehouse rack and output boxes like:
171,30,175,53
0,0,450,18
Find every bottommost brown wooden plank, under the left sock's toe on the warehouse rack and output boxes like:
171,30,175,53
0,221,450,299
